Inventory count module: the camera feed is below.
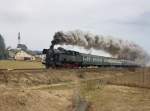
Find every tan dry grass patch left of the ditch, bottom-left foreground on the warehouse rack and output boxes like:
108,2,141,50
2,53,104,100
0,88,72,111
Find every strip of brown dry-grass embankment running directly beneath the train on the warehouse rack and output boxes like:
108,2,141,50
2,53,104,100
0,69,150,88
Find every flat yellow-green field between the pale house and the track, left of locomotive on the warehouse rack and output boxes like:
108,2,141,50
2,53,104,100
0,60,44,69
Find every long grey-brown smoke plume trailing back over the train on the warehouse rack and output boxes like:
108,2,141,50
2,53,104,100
51,30,149,64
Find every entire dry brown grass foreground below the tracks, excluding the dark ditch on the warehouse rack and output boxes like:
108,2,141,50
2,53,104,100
0,69,150,111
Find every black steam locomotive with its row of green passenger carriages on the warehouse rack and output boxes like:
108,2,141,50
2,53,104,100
43,47,140,68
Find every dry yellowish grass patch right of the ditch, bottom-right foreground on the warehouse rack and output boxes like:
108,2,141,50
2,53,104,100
81,85,150,111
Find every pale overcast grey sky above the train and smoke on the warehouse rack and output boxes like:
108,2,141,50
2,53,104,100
0,0,150,53
